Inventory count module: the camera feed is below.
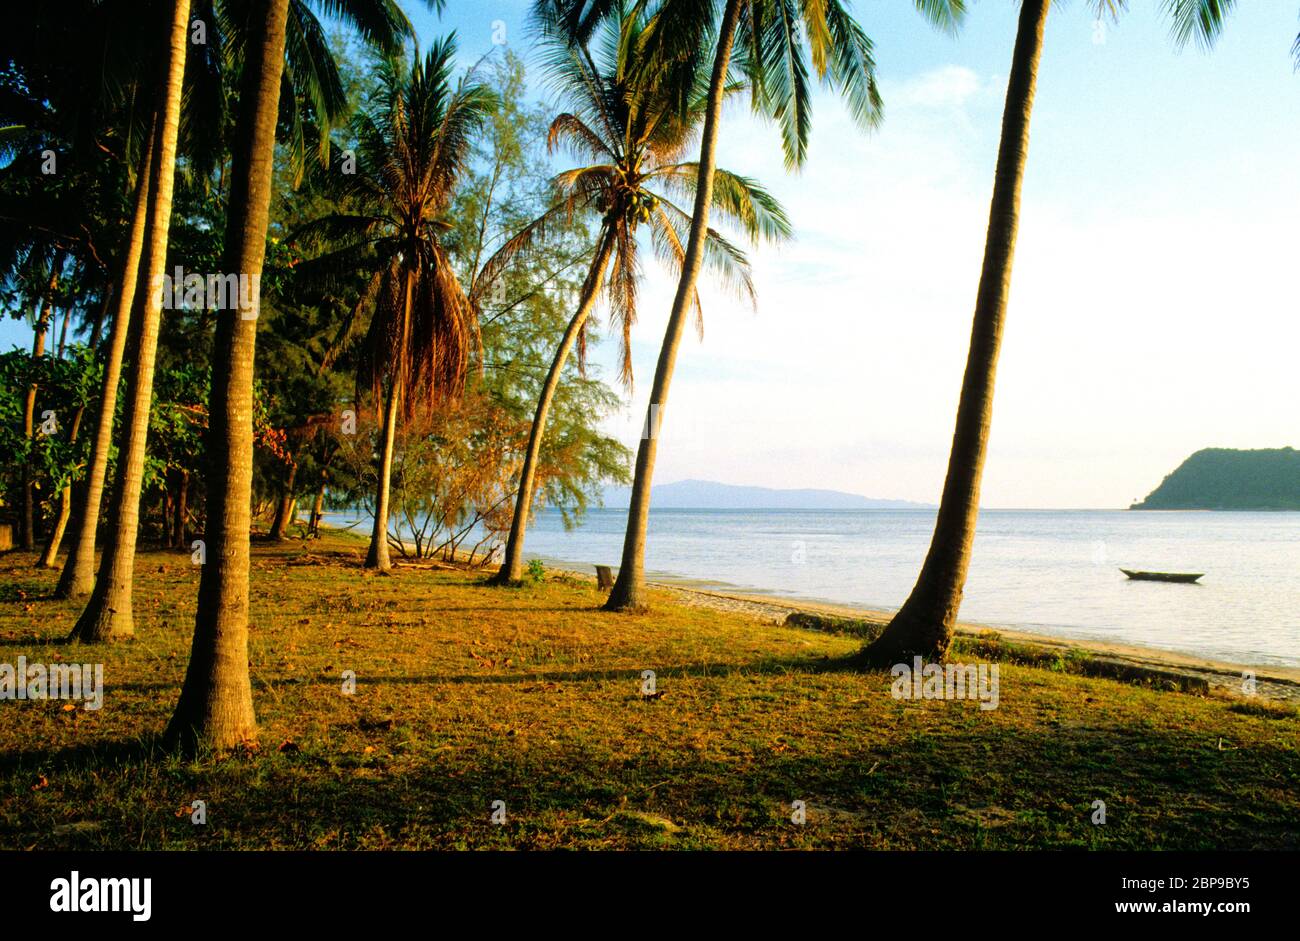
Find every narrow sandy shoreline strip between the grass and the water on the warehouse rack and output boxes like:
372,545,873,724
525,556,1300,704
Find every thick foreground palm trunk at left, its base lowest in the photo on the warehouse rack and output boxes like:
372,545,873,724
164,0,289,750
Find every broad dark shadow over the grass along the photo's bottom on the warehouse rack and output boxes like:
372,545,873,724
12,712,1300,850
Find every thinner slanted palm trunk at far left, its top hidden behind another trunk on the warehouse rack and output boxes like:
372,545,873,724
55,129,156,598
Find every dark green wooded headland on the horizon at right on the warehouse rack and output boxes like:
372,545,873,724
1128,447,1300,509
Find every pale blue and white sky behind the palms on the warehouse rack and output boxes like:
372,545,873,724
0,0,1300,507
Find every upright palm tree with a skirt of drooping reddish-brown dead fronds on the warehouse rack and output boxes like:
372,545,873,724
296,34,497,572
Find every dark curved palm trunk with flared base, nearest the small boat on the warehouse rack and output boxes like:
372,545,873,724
862,0,1050,665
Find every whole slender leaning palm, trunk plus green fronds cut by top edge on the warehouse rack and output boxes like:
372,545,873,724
533,0,963,611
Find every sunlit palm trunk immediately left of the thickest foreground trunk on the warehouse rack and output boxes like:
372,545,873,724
72,0,190,642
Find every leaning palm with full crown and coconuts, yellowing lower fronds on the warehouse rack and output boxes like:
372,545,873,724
488,6,790,584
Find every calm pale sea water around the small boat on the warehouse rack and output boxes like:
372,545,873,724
512,509,1300,667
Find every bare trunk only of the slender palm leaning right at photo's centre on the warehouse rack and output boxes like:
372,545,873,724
605,0,742,611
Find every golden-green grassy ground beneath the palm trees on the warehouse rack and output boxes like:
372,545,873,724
0,537,1300,849
